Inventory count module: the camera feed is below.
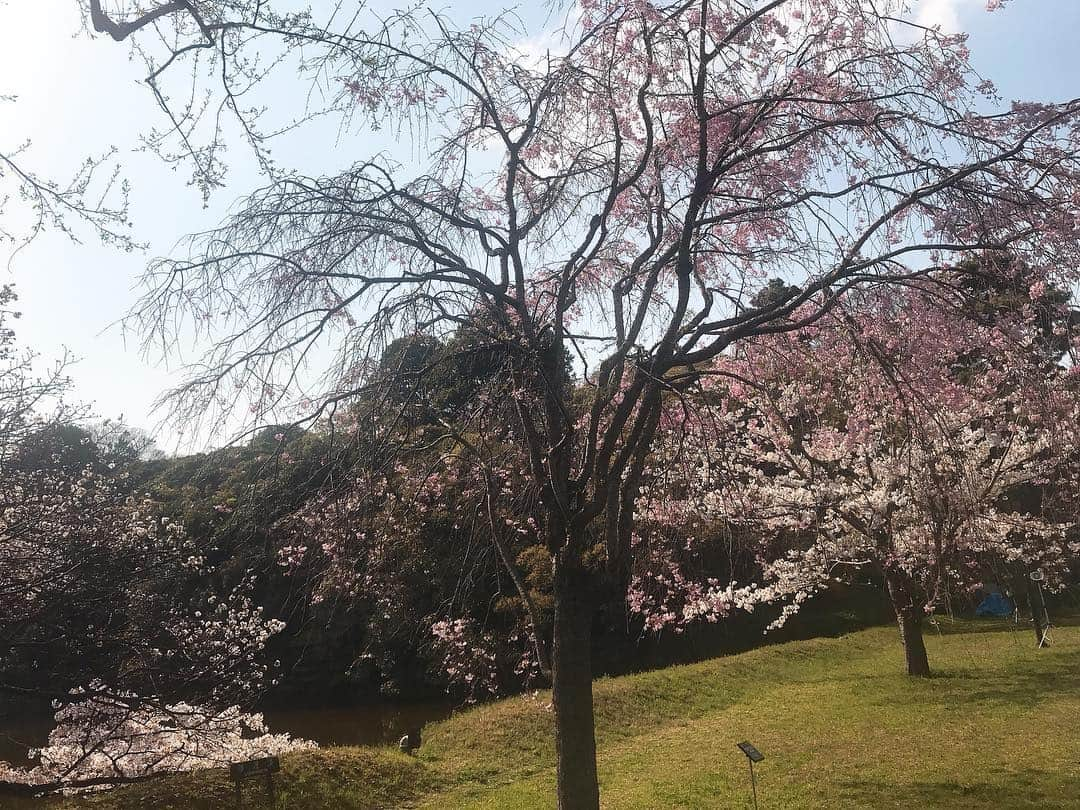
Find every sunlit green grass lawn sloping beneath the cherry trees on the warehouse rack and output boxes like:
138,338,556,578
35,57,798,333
31,623,1080,810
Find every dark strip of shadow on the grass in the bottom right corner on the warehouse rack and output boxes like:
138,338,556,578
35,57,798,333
836,769,1080,810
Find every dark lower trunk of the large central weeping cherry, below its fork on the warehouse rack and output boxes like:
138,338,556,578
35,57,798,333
552,548,600,810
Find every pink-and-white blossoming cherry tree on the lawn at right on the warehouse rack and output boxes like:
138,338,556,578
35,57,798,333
639,278,1080,676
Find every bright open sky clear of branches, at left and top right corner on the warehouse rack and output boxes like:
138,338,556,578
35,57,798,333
0,0,1080,451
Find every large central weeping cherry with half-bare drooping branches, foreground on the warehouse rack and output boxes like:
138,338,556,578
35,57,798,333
95,0,1080,808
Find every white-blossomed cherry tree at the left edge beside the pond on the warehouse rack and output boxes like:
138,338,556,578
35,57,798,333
0,308,299,793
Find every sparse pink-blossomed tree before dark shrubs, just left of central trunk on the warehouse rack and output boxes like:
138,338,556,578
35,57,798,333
275,356,551,700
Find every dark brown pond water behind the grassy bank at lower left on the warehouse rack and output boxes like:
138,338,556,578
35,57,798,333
0,702,453,764
